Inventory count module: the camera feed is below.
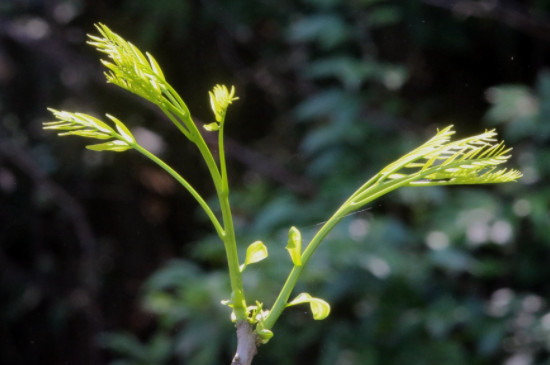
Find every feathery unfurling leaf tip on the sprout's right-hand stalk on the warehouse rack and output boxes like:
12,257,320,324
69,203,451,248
349,125,522,210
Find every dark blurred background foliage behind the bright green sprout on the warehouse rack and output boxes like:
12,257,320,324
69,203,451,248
0,0,550,365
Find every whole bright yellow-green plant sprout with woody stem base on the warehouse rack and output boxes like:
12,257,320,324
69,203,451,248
44,24,522,365
